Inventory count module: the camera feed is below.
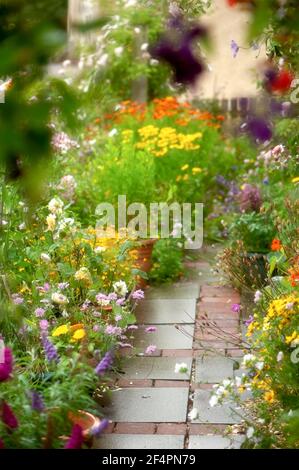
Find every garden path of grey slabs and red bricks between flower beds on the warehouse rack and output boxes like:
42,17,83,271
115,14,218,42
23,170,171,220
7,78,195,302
95,248,246,449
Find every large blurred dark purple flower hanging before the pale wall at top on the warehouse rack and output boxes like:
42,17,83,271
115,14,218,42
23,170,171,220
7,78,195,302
151,21,206,85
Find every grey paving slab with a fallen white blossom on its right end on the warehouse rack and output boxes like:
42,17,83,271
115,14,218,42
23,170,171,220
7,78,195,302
123,357,192,380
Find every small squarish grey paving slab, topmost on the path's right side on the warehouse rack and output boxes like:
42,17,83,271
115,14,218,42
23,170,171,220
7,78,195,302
195,354,238,384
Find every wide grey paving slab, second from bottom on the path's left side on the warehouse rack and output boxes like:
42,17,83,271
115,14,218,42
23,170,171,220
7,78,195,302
104,387,189,423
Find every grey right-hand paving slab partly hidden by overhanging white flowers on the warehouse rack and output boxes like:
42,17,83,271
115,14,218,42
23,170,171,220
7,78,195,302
192,390,244,424
